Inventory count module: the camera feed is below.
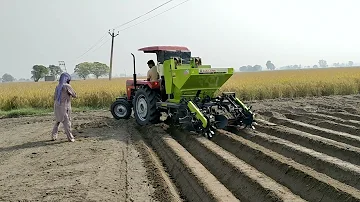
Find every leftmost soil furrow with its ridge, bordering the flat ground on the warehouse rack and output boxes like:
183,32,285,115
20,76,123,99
139,124,239,201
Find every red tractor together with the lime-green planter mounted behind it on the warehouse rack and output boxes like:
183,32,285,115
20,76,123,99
111,46,256,138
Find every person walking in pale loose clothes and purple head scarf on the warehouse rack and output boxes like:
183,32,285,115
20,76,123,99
52,73,76,142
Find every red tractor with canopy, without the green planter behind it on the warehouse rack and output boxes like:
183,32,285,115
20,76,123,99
111,46,191,125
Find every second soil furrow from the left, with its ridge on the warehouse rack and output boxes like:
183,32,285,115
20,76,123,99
172,128,304,201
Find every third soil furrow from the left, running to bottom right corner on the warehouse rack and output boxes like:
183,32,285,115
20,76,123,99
212,130,360,201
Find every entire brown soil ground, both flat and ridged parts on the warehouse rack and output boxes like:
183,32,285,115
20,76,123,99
0,96,360,202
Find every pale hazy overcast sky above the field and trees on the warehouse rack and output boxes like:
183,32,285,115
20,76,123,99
0,0,360,79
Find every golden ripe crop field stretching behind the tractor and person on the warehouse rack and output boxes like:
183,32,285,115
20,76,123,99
0,67,360,111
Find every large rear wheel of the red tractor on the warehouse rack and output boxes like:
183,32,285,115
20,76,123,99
133,87,160,126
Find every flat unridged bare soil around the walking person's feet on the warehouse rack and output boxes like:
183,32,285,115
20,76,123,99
0,111,180,201
